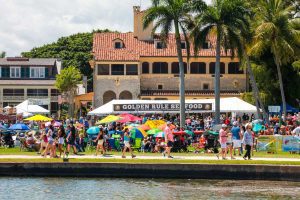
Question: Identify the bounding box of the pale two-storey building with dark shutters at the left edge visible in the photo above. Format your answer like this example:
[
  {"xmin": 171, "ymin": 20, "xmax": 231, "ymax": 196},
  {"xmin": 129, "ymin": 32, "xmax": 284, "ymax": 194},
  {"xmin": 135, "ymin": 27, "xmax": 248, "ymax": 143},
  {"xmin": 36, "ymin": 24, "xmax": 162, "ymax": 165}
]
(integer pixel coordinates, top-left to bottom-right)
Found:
[{"xmin": 0, "ymin": 57, "xmax": 61, "ymax": 113}]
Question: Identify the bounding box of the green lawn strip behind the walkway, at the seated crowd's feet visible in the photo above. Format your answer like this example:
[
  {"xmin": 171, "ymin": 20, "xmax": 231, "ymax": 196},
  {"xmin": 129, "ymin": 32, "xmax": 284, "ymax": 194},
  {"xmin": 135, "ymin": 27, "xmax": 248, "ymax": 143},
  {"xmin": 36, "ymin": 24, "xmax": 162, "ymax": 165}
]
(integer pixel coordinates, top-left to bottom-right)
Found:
[{"xmin": 0, "ymin": 147, "xmax": 300, "ymax": 159}]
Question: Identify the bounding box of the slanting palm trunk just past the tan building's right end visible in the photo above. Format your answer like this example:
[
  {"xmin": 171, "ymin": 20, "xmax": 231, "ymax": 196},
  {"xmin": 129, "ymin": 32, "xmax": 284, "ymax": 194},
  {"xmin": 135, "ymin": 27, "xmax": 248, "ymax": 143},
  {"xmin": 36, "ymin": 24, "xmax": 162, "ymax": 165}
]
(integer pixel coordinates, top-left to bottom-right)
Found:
[{"xmin": 244, "ymin": 53, "xmax": 270, "ymax": 124}]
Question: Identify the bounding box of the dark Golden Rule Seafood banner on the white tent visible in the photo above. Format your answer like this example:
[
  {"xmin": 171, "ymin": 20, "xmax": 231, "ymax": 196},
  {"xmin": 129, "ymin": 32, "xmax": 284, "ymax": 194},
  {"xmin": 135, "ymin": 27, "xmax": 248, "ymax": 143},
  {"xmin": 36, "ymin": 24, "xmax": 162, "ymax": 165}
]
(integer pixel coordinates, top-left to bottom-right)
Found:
[{"xmin": 113, "ymin": 103, "xmax": 212, "ymax": 112}]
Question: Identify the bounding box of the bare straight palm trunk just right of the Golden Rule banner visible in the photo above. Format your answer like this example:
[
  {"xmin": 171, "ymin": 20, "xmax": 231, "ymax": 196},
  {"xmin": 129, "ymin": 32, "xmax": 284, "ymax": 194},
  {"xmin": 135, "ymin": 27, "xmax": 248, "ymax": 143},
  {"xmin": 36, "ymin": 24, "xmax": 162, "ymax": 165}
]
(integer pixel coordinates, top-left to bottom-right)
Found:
[{"xmin": 215, "ymin": 30, "xmax": 221, "ymax": 124}]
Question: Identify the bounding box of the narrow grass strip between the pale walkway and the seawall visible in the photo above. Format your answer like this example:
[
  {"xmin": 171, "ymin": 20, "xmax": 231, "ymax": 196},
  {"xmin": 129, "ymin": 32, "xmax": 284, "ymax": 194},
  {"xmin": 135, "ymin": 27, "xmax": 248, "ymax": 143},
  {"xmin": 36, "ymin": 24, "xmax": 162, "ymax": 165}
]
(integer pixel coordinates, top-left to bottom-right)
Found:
[{"xmin": 0, "ymin": 158, "xmax": 300, "ymax": 166}]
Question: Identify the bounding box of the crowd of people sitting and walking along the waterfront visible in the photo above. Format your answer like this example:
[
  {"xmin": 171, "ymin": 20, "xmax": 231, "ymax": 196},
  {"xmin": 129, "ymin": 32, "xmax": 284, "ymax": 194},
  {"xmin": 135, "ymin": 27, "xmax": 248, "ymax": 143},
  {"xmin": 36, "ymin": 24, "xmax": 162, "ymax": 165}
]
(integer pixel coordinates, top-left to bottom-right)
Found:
[{"xmin": 2, "ymin": 113, "xmax": 300, "ymax": 160}]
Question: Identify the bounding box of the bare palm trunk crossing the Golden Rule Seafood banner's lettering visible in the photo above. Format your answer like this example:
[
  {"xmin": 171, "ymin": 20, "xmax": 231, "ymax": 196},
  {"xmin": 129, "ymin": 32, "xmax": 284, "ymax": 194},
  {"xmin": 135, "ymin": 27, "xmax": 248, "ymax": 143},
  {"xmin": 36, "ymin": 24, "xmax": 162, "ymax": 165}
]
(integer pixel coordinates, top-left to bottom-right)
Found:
[{"xmin": 174, "ymin": 21, "xmax": 185, "ymax": 128}]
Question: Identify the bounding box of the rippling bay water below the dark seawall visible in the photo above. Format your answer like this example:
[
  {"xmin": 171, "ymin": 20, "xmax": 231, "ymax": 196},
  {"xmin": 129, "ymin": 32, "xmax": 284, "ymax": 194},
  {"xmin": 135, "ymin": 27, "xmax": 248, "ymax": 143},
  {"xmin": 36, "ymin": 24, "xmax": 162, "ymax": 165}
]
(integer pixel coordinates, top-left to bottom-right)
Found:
[{"xmin": 0, "ymin": 177, "xmax": 300, "ymax": 200}]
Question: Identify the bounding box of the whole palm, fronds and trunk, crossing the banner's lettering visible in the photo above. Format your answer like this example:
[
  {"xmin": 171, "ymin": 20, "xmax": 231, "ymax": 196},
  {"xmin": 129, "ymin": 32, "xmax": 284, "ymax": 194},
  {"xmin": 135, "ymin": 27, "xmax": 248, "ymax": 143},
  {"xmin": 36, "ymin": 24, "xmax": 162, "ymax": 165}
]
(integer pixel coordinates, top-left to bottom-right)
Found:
[{"xmin": 143, "ymin": 0, "xmax": 205, "ymax": 127}]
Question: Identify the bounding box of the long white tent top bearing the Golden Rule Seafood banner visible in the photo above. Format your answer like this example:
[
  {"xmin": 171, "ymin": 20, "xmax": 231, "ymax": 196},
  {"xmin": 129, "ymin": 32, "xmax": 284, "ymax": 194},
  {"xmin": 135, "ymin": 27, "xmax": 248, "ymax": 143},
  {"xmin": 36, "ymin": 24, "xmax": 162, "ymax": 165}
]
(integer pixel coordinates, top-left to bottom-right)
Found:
[{"xmin": 88, "ymin": 97, "xmax": 256, "ymax": 116}]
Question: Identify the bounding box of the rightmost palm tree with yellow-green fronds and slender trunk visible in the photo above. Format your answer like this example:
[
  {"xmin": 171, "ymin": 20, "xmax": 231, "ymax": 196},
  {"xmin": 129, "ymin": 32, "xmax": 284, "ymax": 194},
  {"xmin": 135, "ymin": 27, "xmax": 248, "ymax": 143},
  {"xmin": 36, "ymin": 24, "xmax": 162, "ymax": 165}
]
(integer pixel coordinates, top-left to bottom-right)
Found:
[{"xmin": 250, "ymin": 0, "xmax": 300, "ymax": 119}]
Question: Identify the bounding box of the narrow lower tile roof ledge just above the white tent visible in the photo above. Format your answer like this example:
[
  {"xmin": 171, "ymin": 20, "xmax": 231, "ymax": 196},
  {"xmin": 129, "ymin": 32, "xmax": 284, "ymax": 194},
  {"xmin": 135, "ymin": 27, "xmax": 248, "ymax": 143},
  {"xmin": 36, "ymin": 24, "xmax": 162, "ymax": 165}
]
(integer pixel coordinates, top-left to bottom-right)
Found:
[{"xmin": 141, "ymin": 90, "xmax": 240, "ymax": 96}]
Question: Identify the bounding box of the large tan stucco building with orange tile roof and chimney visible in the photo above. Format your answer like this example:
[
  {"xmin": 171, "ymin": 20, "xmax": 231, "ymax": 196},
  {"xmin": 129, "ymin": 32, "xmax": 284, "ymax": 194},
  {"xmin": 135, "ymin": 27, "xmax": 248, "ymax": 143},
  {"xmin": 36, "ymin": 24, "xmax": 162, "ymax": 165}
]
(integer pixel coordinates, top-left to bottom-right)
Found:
[{"xmin": 91, "ymin": 7, "xmax": 246, "ymax": 107}]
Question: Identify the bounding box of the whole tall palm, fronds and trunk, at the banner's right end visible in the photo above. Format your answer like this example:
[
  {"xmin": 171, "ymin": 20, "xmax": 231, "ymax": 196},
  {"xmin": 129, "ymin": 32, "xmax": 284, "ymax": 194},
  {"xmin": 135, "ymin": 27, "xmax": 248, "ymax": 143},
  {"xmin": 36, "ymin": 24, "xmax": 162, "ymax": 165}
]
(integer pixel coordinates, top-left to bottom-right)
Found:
[{"xmin": 192, "ymin": 0, "xmax": 248, "ymax": 124}]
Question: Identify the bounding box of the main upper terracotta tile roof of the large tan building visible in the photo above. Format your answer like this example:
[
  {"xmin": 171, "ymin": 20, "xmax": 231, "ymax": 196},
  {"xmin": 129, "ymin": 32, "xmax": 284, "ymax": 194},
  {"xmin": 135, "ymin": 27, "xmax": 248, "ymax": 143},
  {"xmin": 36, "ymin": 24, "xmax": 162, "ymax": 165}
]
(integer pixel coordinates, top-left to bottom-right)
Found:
[{"xmin": 93, "ymin": 33, "xmax": 229, "ymax": 61}]
